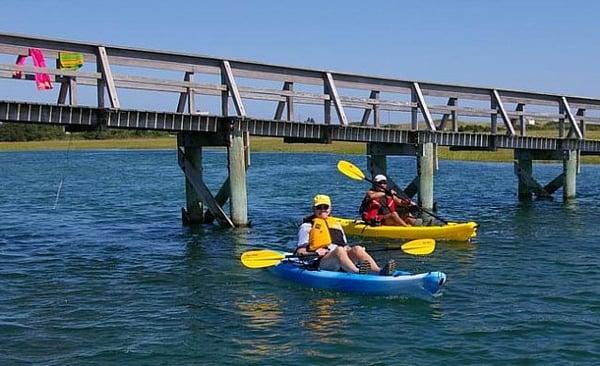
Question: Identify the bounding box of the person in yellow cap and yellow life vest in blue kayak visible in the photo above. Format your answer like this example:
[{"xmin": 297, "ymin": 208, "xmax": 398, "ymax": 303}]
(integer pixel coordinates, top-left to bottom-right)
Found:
[{"xmin": 296, "ymin": 194, "xmax": 396, "ymax": 275}]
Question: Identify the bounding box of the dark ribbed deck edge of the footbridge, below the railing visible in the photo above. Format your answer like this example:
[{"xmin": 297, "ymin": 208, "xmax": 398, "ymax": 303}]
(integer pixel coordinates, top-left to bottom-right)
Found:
[{"xmin": 0, "ymin": 101, "xmax": 600, "ymax": 155}]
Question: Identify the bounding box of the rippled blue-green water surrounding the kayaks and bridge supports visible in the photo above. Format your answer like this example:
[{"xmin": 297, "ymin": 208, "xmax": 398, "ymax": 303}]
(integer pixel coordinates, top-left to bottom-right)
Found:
[{"xmin": 0, "ymin": 151, "xmax": 600, "ymax": 365}]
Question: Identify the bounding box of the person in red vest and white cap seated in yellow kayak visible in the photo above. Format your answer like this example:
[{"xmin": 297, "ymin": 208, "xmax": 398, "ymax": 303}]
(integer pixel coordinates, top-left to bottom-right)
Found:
[{"xmin": 359, "ymin": 174, "xmax": 422, "ymax": 226}]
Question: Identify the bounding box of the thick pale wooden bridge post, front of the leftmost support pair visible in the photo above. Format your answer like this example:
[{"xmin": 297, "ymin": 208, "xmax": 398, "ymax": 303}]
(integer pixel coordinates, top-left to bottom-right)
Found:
[{"xmin": 227, "ymin": 130, "xmax": 249, "ymax": 227}]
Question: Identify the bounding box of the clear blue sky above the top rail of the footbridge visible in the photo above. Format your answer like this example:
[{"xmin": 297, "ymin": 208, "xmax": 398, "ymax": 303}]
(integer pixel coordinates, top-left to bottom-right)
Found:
[{"xmin": 0, "ymin": 0, "xmax": 600, "ymax": 106}]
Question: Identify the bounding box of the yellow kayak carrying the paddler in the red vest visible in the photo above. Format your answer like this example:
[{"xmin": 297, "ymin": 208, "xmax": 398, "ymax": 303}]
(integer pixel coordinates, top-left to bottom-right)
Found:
[{"xmin": 335, "ymin": 217, "xmax": 477, "ymax": 241}]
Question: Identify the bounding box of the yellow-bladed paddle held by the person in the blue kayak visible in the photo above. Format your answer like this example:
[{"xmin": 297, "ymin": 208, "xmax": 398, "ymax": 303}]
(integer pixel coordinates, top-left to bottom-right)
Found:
[{"xmin": 241, "ymin": 239, "xmax": 435, "ymax": 268}]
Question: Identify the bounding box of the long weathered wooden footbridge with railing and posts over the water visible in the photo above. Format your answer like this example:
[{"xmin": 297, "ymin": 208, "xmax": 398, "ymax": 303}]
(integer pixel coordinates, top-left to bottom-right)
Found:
[{"xmin": 0, "ymin": 33, "xmax": 600, "ymax": 226}]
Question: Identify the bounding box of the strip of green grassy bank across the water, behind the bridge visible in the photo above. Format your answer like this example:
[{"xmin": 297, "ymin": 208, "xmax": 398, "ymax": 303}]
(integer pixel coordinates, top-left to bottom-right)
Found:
[{"xmin": 0, "ymin": 136, "xmax": 600, "ymax": 164}]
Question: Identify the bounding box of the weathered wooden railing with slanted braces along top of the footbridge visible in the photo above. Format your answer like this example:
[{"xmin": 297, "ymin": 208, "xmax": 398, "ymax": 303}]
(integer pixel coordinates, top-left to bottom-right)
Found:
[{"xmin": 0, "ymin": 33, "xmax": 600, "ymax": 140}]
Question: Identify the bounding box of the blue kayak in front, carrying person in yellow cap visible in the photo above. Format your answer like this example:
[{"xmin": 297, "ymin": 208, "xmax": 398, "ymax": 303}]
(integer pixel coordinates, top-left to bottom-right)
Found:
[{"xmin": 269, "ymin": 260, "xmax": 446, "ymax": 299}]
